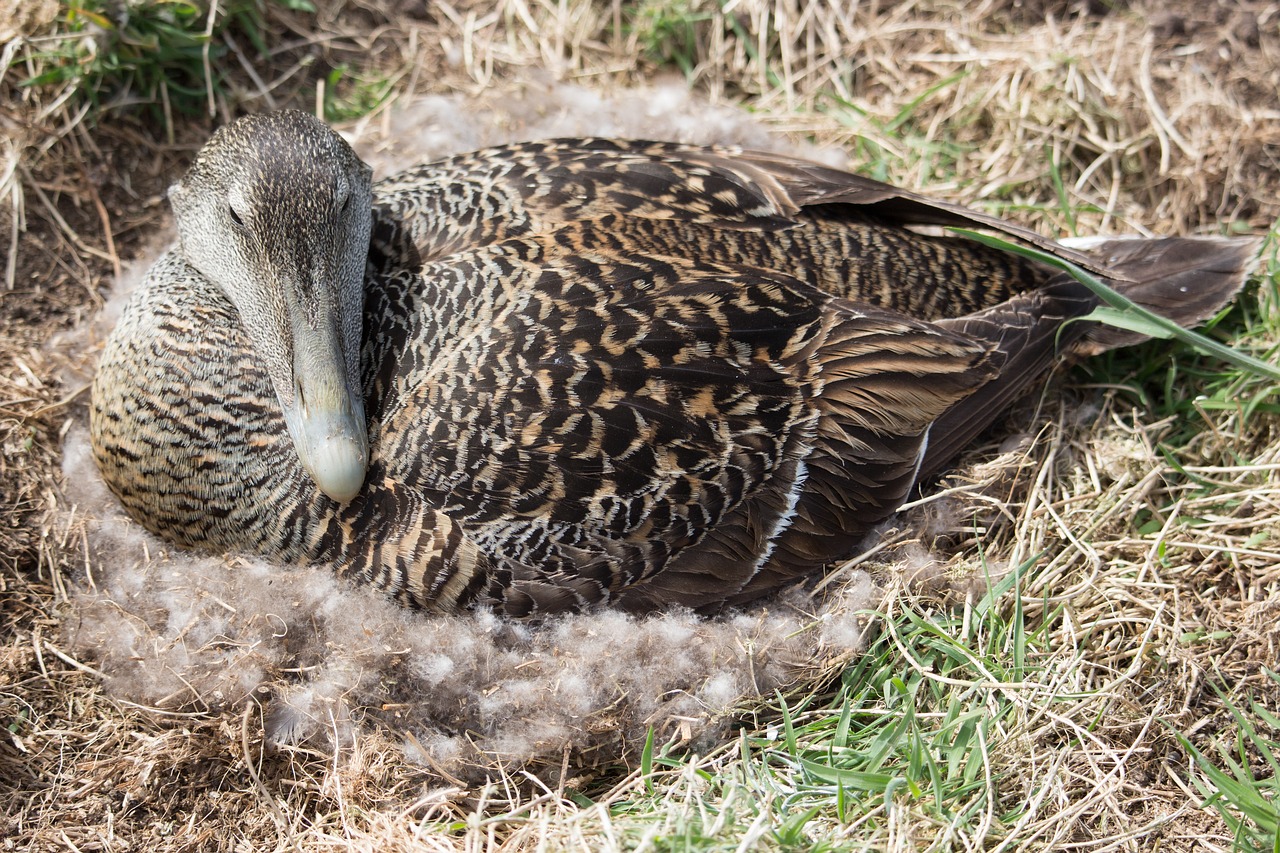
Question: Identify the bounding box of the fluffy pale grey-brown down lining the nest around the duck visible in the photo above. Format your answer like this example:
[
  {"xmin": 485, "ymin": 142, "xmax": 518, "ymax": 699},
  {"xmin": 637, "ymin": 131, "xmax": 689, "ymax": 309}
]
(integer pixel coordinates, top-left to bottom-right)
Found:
[{"xmin": 64, "ymin": 86, "xmax": 877, "ymax": 776}]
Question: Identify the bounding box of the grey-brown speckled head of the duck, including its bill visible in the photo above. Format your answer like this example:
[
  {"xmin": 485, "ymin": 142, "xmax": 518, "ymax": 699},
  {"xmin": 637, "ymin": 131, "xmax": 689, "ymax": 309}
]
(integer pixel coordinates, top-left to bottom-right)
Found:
[{"xmin": 169, "ymin": 110, "xmax": 372, "ymax": 502}]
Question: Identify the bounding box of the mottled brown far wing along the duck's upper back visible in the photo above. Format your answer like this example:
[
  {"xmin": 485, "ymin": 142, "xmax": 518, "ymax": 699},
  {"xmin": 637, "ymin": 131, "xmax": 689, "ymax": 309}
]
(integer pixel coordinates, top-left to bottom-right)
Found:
[{"xmin": 375, "ymin": 138, "xmax": 1105, "ymax": 273}]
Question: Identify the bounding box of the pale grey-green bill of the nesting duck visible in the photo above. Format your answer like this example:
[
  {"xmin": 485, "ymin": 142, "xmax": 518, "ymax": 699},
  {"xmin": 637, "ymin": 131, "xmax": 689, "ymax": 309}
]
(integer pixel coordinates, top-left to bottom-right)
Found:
[{"xmin": 284, "ymin": 322, "xmax": 369, "ymax": 503}]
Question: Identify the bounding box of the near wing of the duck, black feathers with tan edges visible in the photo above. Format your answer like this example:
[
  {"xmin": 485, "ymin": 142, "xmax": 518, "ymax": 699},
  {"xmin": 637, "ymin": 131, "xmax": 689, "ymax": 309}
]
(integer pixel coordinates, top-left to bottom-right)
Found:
[{"xmin": 334, "ymin": 216, "xmax": 998, "ymax": 615}]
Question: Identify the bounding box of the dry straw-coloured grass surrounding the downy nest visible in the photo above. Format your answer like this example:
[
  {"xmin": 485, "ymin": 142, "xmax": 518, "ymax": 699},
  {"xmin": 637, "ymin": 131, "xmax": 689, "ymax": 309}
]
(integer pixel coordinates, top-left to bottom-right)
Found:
[{"xmin": 0, "ymin": 0, "xmax": 1280, "ymax": 850}]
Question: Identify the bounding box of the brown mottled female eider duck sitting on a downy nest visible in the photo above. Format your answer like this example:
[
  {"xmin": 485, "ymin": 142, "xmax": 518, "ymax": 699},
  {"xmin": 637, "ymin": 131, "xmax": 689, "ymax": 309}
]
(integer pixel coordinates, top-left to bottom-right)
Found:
[{"xmin": 91, "ymin": 111, "xmax": 1256, "ymax": 617}]
